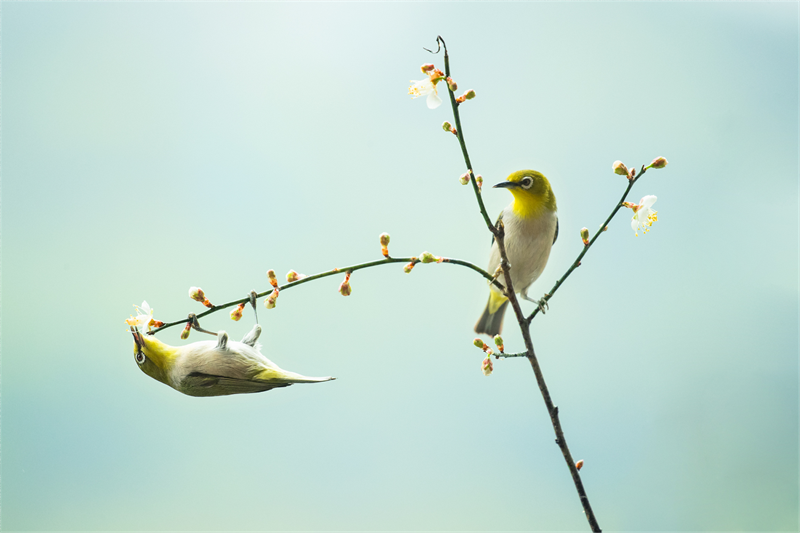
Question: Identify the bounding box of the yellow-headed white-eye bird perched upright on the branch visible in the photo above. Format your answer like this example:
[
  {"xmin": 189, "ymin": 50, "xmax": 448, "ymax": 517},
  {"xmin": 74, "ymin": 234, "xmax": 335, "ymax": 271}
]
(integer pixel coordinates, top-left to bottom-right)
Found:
[{"xmin": 475, "ymin": 170, "xmax": 558, "ymax": 336}]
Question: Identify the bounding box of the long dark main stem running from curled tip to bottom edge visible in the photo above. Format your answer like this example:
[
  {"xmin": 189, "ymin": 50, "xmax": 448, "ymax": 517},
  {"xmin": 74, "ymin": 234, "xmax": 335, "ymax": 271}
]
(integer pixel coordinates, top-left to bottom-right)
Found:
[{"xmin": 437, "ymin": 37, "xmax": 600, "ymax": 533}]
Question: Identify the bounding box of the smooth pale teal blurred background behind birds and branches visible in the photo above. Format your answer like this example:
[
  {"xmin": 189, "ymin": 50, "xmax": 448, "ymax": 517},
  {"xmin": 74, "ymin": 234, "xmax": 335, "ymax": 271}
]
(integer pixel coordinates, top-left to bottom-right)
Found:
[{"xmin": 0, "ymin": 2, "xmax": 800, "ymax": 531}]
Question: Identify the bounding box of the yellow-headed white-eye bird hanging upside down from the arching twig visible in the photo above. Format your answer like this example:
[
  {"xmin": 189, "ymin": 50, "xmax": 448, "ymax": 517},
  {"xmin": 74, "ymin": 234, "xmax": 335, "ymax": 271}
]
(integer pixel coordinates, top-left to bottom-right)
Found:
[{"xmin": 131, "ymin": 324, "xmax": 336, "ymax": 396}]
